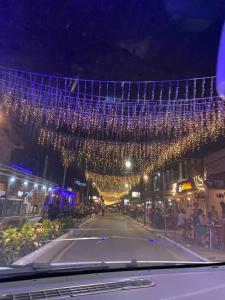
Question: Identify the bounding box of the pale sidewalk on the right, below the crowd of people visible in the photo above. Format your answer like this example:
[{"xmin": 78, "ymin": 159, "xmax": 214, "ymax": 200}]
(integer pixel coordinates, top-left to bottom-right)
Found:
[{"xmin": 128, "ymin": 216, "xmax": 225, "ymax": 262}]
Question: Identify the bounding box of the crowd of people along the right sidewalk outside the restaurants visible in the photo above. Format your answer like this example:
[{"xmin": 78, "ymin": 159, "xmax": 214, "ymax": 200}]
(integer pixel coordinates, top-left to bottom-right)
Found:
[{"xmin": 126, "ymin": 202, "xmax": 225, "ymax": 248}]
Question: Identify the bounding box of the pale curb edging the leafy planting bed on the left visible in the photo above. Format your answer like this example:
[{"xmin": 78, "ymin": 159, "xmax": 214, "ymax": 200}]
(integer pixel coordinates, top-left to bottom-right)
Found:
[{"xmin": 12, "ymin": 217, "xmax": 94, "ymax": 266}]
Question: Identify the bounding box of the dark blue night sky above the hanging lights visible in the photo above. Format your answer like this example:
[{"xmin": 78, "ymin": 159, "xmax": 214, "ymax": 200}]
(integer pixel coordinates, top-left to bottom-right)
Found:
[{"xmin": 0, "ymin": 0, "xmax": 225, "ymax": 184}]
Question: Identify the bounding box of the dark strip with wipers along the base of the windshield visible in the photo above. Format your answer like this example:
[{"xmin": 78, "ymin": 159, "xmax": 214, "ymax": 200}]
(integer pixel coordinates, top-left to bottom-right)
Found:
[{"xmin": 0, "ymin": 259, "xmax": 221, "ymax": 282}]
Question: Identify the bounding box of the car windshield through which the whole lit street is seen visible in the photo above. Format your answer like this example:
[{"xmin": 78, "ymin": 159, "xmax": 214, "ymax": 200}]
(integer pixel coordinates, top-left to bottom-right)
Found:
[{"xmin": 0, "ymin": 0, "xmax": 225, "ymax": 272}]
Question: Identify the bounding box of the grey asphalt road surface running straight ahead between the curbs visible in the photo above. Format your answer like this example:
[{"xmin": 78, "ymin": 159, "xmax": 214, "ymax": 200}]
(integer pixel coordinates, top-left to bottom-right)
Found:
[{"xmin": 38, "ymin": 213, "xmax": 202, "ymax": 263}]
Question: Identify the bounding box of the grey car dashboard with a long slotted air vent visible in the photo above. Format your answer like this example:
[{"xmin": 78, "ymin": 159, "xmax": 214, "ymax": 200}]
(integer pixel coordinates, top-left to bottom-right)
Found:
[{"xmin": 0, "ymin": 266, "xmax": 225, "ymax": 300}]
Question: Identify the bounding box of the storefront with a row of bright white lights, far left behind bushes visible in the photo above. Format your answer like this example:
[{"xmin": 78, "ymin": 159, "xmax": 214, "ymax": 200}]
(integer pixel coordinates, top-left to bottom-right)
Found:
[{"xmin": 0, "ymin": 164, "xmax": 54, "ymax": 217}]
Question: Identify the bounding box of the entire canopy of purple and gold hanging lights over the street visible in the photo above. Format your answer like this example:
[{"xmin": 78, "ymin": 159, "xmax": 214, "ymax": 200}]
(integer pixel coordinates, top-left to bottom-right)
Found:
[{"xmin": 0, "ymin": 67, "xmax": 225, "ymax": 201}]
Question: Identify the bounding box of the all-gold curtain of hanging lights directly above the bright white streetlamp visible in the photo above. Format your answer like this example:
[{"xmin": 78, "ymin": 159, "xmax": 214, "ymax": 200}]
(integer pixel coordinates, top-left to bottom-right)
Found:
[{"xmin": 38, "ymin": 128, "xmax": 169, "ymax": 174}]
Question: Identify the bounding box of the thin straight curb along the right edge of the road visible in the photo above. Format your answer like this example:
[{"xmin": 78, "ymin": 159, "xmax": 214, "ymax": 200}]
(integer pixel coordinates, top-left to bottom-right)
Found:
[{"xmin": 126, "ymin": 216, "xmax": 209, "ymax": 262}]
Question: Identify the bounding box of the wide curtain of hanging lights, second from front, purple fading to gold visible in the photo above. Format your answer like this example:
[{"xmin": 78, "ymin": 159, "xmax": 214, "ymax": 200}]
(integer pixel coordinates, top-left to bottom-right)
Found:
[{"xmin": 5, "ymin": 96, "xmax": 225, "ymax": 142}]
